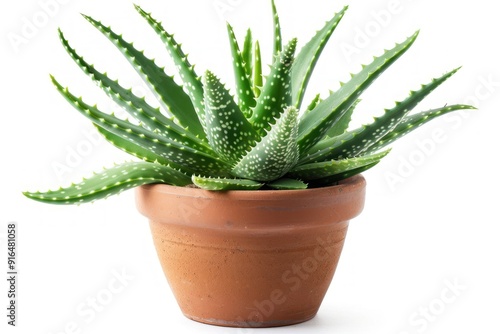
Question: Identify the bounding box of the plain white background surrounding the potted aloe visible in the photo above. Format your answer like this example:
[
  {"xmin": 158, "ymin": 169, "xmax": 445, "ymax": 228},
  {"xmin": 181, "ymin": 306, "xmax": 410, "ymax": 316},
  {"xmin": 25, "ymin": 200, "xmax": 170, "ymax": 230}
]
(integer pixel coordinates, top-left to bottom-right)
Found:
[{"xmin": 0, "ymin": 0, "xmax": 500, "ymax": 334}]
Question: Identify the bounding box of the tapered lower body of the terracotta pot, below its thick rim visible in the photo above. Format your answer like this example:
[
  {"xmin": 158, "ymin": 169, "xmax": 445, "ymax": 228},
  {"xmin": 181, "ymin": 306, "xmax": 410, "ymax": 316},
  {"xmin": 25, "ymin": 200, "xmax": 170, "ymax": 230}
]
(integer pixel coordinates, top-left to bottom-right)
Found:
[{"xmin": 150, "ymin": 221, "xmax": 348, "ymax": 327}]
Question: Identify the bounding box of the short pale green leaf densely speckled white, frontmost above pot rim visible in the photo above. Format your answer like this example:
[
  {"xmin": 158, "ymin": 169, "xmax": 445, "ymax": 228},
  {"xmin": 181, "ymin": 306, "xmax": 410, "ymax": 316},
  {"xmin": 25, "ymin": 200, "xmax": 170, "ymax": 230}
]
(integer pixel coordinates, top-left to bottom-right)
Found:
[{"xmin": 232, "ymin": 107, "xmax": 298, "ymax": 181}]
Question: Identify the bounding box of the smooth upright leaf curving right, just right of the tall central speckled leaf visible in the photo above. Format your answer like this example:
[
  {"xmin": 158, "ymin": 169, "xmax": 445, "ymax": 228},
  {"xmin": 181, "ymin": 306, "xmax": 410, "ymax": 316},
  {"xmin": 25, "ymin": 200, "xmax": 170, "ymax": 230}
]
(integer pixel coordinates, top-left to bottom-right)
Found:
[{"xmin": 292, "ymin": 6, "xmax": 348, "ymax": 109}]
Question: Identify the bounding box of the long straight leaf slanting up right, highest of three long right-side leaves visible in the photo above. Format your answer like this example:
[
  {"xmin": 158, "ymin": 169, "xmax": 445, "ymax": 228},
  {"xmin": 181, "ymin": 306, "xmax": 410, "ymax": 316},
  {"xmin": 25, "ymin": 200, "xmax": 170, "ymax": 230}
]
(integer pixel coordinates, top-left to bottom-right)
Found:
[{"xmin": 299, "ymin": 32, "xmax": 418, "ymax": 156}]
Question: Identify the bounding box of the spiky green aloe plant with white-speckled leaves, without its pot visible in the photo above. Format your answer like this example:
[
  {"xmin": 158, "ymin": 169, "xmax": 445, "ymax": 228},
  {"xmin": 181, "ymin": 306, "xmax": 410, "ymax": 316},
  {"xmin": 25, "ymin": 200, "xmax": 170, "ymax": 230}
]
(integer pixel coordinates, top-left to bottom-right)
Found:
[{"xmin": 25, "ymin": 1, "xmax": 473, "ymax": 204}]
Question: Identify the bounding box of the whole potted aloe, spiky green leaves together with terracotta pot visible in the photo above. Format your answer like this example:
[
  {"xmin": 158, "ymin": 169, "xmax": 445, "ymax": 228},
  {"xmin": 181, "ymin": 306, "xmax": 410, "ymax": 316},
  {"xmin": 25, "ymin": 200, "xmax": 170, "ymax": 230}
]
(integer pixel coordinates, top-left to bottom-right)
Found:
[{"xmin": 25, "ymin": 2, "xmax": 474, "ymax": 327}]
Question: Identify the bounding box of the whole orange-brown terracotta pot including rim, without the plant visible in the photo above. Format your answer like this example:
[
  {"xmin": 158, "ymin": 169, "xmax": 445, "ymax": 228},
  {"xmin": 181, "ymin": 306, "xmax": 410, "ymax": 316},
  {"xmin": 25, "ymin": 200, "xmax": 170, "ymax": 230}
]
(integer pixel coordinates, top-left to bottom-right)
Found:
[{"xmin": 136, "ymin": 175, "xmax": 366, "ymax": 327}]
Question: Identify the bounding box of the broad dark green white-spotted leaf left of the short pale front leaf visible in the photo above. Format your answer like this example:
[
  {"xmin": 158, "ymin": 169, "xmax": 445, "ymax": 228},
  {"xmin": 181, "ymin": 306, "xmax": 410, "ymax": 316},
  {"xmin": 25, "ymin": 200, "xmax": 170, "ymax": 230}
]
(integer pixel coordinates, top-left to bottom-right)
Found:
[{"xmin": 204, "ymin": 71, "xmax": 259, "ymax": 164}]
